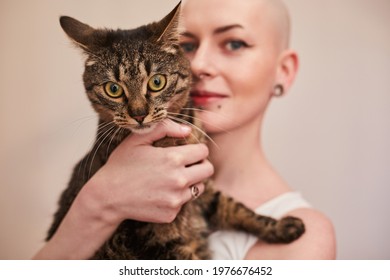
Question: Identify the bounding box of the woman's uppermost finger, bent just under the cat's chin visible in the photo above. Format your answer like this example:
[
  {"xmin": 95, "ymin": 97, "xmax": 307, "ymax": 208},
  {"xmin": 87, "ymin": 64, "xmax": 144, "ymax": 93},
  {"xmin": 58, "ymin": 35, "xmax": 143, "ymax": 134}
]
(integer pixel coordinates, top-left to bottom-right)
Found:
[{"xmin": 131, "ymin": 120, "xmax": 191, "ymax": 145}]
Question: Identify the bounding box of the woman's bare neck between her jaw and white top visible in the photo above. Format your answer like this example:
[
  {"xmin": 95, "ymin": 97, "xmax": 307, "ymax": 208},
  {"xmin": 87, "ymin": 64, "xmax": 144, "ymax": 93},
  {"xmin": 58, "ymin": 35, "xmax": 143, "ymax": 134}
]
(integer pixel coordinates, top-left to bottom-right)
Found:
[{"xmin": 209, "ymin": 116, "xmax": 288, "ymax": 208}]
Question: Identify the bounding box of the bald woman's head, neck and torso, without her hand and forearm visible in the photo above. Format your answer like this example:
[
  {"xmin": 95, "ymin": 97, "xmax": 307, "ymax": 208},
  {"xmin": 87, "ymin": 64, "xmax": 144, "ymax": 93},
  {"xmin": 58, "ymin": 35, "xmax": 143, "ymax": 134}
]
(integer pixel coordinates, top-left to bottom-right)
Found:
[{"xmin": 181, "ymin": 0, "xmax": 335, "ymax": 259}]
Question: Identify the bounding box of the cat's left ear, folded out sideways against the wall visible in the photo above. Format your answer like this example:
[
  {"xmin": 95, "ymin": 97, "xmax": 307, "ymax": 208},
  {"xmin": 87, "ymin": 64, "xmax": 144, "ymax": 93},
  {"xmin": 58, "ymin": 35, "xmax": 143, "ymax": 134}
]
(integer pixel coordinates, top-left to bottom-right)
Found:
[{"xmin": 60, "ymin": 16, "xmax": 106, "ymax": 52}]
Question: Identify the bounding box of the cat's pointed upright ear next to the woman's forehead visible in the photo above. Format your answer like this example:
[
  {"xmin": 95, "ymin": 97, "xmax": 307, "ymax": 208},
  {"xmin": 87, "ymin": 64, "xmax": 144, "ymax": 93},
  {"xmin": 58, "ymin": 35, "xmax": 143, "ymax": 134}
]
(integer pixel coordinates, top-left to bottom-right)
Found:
[{"xmin": 157, "ymin": 1, "xmax": 181, "ymax": 49}]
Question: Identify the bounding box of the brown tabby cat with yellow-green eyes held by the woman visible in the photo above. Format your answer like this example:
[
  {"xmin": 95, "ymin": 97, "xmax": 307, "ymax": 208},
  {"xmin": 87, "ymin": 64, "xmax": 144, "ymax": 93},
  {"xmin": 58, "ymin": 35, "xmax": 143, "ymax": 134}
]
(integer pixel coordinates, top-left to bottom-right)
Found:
[{"xmin": 47, "ymin": 3, "xmax": 304, "ymax": 259}]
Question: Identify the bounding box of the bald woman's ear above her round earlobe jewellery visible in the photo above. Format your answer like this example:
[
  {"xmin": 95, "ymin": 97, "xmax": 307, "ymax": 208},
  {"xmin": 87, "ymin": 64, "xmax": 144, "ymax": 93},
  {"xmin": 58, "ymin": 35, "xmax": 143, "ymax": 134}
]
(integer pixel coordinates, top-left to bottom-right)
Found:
[{"xmin": 276, "ymin": 49, "xmax": 299, "ymax": 92}]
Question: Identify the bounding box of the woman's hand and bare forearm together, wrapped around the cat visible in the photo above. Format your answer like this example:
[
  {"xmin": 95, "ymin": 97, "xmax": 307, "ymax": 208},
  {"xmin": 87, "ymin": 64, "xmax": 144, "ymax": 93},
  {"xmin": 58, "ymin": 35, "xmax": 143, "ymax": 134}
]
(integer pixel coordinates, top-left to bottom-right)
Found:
[{"xmin": 34, "ymin": 121, "xmax": 213, "ymax": 259}]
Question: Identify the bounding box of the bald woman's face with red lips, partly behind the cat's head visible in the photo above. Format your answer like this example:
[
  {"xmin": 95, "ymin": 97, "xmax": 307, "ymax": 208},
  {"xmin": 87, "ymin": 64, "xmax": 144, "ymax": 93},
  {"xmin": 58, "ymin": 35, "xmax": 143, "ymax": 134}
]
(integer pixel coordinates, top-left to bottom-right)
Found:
[{"xmin": 181, "ymin": 0, "xmax": 280, "ymax": 134}]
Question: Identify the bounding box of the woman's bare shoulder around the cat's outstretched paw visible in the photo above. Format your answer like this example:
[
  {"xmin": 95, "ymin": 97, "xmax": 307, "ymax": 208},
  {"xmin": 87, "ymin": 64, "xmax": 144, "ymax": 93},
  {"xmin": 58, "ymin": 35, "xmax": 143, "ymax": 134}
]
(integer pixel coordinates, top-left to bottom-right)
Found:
[{"xmin": 246, "ymin": 208, "xmax": 336, "ymax": 259}]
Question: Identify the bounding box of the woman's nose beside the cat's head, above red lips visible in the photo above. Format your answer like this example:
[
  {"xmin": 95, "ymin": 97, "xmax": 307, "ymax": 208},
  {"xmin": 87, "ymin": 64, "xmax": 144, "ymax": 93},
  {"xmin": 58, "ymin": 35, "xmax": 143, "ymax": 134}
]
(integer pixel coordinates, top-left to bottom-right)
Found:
[{"xmin": 191, "ymin": 44, "xmax": 216, "ymax": 78}]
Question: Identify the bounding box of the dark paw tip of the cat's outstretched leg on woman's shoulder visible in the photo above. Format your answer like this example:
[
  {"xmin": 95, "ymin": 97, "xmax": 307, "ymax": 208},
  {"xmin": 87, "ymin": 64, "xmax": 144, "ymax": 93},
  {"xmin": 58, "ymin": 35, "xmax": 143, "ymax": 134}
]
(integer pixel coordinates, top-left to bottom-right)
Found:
[{"xmin": 275, "ymin": 216, "xmax": 305, "ymax": 243}]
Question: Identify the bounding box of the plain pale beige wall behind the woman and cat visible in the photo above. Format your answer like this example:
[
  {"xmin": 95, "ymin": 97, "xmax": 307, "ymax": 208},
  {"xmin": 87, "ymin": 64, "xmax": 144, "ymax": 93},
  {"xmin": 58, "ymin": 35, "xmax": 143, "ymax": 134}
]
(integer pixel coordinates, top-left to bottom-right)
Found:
[{"xmin": 0, "ymin": 0, "xmax": 390, "ymax": 259}]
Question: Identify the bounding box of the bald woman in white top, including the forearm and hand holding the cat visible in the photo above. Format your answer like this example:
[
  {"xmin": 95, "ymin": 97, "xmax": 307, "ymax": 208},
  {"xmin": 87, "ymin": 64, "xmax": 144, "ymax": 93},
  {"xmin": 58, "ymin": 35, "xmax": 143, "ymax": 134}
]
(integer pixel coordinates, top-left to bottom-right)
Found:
[{"xmin": 36, "ymin": 0, "xmax": 335, "ymax": 259}]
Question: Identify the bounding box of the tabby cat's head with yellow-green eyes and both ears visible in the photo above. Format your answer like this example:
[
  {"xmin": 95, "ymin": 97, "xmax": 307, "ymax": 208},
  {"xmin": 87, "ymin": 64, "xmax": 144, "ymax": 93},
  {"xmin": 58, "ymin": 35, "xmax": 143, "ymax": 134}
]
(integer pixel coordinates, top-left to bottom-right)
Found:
[{"xmin": 60, "ymin": 3, "xmax": 191, "ymax": 133}]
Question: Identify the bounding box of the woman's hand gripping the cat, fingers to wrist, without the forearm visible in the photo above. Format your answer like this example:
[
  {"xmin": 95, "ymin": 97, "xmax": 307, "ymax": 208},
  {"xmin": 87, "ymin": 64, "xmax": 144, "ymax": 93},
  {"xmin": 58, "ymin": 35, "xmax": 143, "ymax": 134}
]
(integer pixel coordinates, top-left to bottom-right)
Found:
[{"xmin": 82, "ymin": 121, "xmax": 213, "ymax": 223}]
